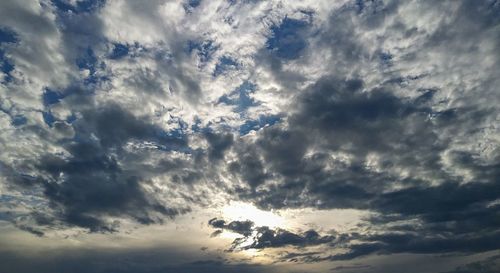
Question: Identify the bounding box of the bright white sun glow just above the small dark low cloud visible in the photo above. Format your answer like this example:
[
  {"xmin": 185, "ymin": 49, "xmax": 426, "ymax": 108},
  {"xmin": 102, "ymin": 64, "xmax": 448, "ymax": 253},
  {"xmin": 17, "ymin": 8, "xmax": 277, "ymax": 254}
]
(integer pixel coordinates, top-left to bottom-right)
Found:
[{"xmin": 222, "ymin": 202, "xmax": 286, "ymax": 228}]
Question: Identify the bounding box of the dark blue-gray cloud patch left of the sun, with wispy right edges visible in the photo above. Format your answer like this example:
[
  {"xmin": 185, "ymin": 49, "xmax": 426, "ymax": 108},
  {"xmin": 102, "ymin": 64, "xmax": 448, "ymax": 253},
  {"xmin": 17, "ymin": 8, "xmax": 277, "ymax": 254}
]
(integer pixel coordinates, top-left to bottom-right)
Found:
[{"xmin": 14, "ymin": 105, "xmax": 187, "ymax": 231}]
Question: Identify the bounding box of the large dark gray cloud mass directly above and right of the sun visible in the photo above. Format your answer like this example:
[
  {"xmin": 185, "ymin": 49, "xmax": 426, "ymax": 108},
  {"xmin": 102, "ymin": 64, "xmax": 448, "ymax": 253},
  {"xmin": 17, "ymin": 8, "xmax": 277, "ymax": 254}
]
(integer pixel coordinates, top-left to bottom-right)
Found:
[{"xmin": 235, "ymin": 76, "xmax": 446, "ymax": 208}]
